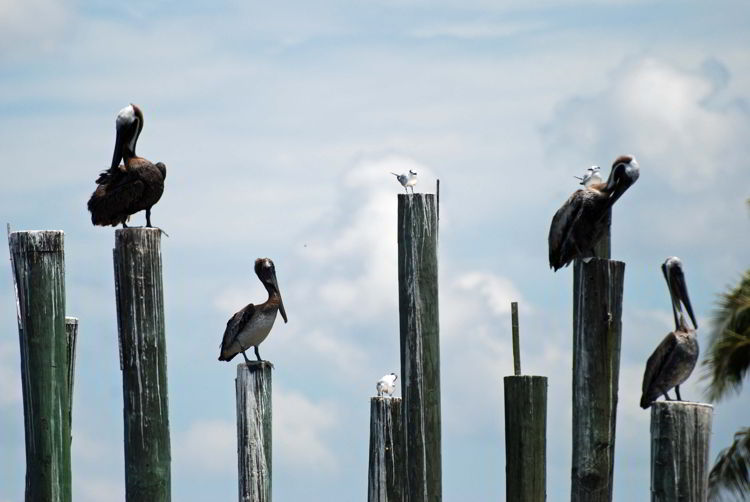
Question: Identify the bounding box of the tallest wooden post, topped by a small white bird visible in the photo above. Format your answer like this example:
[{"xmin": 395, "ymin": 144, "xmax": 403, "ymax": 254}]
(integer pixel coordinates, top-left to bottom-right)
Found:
[{"xmin": 398, "ymin": 193, "xmax": 442, "ymax": 502}]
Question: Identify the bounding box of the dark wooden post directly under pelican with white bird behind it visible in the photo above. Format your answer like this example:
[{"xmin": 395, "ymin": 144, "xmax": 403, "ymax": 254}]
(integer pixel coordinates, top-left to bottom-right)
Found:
[{"xmin": 571, "ymin": 258, "xmax": 625, "ymax": 502}]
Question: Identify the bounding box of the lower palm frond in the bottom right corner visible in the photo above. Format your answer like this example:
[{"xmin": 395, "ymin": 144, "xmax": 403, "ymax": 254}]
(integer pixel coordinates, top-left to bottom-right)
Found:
[{"xmin": 708, "ymin": 427, "xmax": 750, "ymax": 502}]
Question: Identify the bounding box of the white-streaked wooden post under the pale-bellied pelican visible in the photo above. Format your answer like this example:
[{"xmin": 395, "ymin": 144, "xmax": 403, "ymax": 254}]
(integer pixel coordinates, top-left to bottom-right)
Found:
[{"xmin": 235, "ymin": 361, "xmax": 272, "ymax": 502}]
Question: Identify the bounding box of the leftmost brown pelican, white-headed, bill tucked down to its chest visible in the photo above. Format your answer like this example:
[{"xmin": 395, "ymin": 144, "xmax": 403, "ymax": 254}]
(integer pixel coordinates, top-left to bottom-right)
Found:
[{"xmin": 88, "ymin": 104, "xmax": 167, "ymax": 228}]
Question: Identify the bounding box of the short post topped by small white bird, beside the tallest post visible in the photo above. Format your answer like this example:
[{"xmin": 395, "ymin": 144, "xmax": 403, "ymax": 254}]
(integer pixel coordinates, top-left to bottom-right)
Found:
[{"xmin": 367, "ymin": 397, "xmax": 406, "ymax": 502}]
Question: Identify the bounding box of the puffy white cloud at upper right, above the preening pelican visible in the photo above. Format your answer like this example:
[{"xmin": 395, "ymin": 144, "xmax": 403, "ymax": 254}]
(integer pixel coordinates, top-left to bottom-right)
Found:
[{"xmin": 548, "ymin": 58, "xmax": 750, "ymax": 193}]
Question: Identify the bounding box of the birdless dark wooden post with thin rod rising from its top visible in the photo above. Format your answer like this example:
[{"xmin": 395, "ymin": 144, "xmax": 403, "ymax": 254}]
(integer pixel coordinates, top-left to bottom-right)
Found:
[{"xmin": 503, "ymin": 302, "xmax": 547, "ymax": 502}]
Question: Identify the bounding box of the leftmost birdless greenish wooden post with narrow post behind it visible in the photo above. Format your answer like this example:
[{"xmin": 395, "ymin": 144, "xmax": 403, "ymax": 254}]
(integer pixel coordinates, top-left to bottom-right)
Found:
[{"xmin": 8, "ymin": 230, "xmax": 74, "ymax": 502}]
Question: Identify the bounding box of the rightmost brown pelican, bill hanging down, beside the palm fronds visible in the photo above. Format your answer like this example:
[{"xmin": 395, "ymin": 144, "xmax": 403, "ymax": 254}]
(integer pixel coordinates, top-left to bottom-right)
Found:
[{"xmin": 641, "ymin": 256, "xmax": 698, "ymax": 409}]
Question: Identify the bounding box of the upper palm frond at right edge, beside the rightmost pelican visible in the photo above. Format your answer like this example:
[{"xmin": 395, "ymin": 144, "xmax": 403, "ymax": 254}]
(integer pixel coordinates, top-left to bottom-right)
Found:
[{"xmin": 702, "ymin": 270, "xmax": 750, "ymax": 401}]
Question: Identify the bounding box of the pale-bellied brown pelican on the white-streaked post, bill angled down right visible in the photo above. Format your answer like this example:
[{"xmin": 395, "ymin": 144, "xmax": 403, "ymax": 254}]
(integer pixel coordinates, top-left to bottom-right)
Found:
[{"xmin": 219, "ymin": 258, "xmax": 287, "ymax": 363}]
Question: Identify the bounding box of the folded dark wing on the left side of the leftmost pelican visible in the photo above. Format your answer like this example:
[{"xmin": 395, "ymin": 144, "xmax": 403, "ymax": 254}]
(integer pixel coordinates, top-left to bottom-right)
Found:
[{"xmin": 88, "ymin": 168, "xmax": 144, "ymax": 226}]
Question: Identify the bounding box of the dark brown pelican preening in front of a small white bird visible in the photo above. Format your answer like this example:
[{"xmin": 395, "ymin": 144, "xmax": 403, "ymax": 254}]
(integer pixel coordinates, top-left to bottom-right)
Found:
[{"xmin": 549, "ymin": 155, "xmax": 639, "ymax": 271}]
